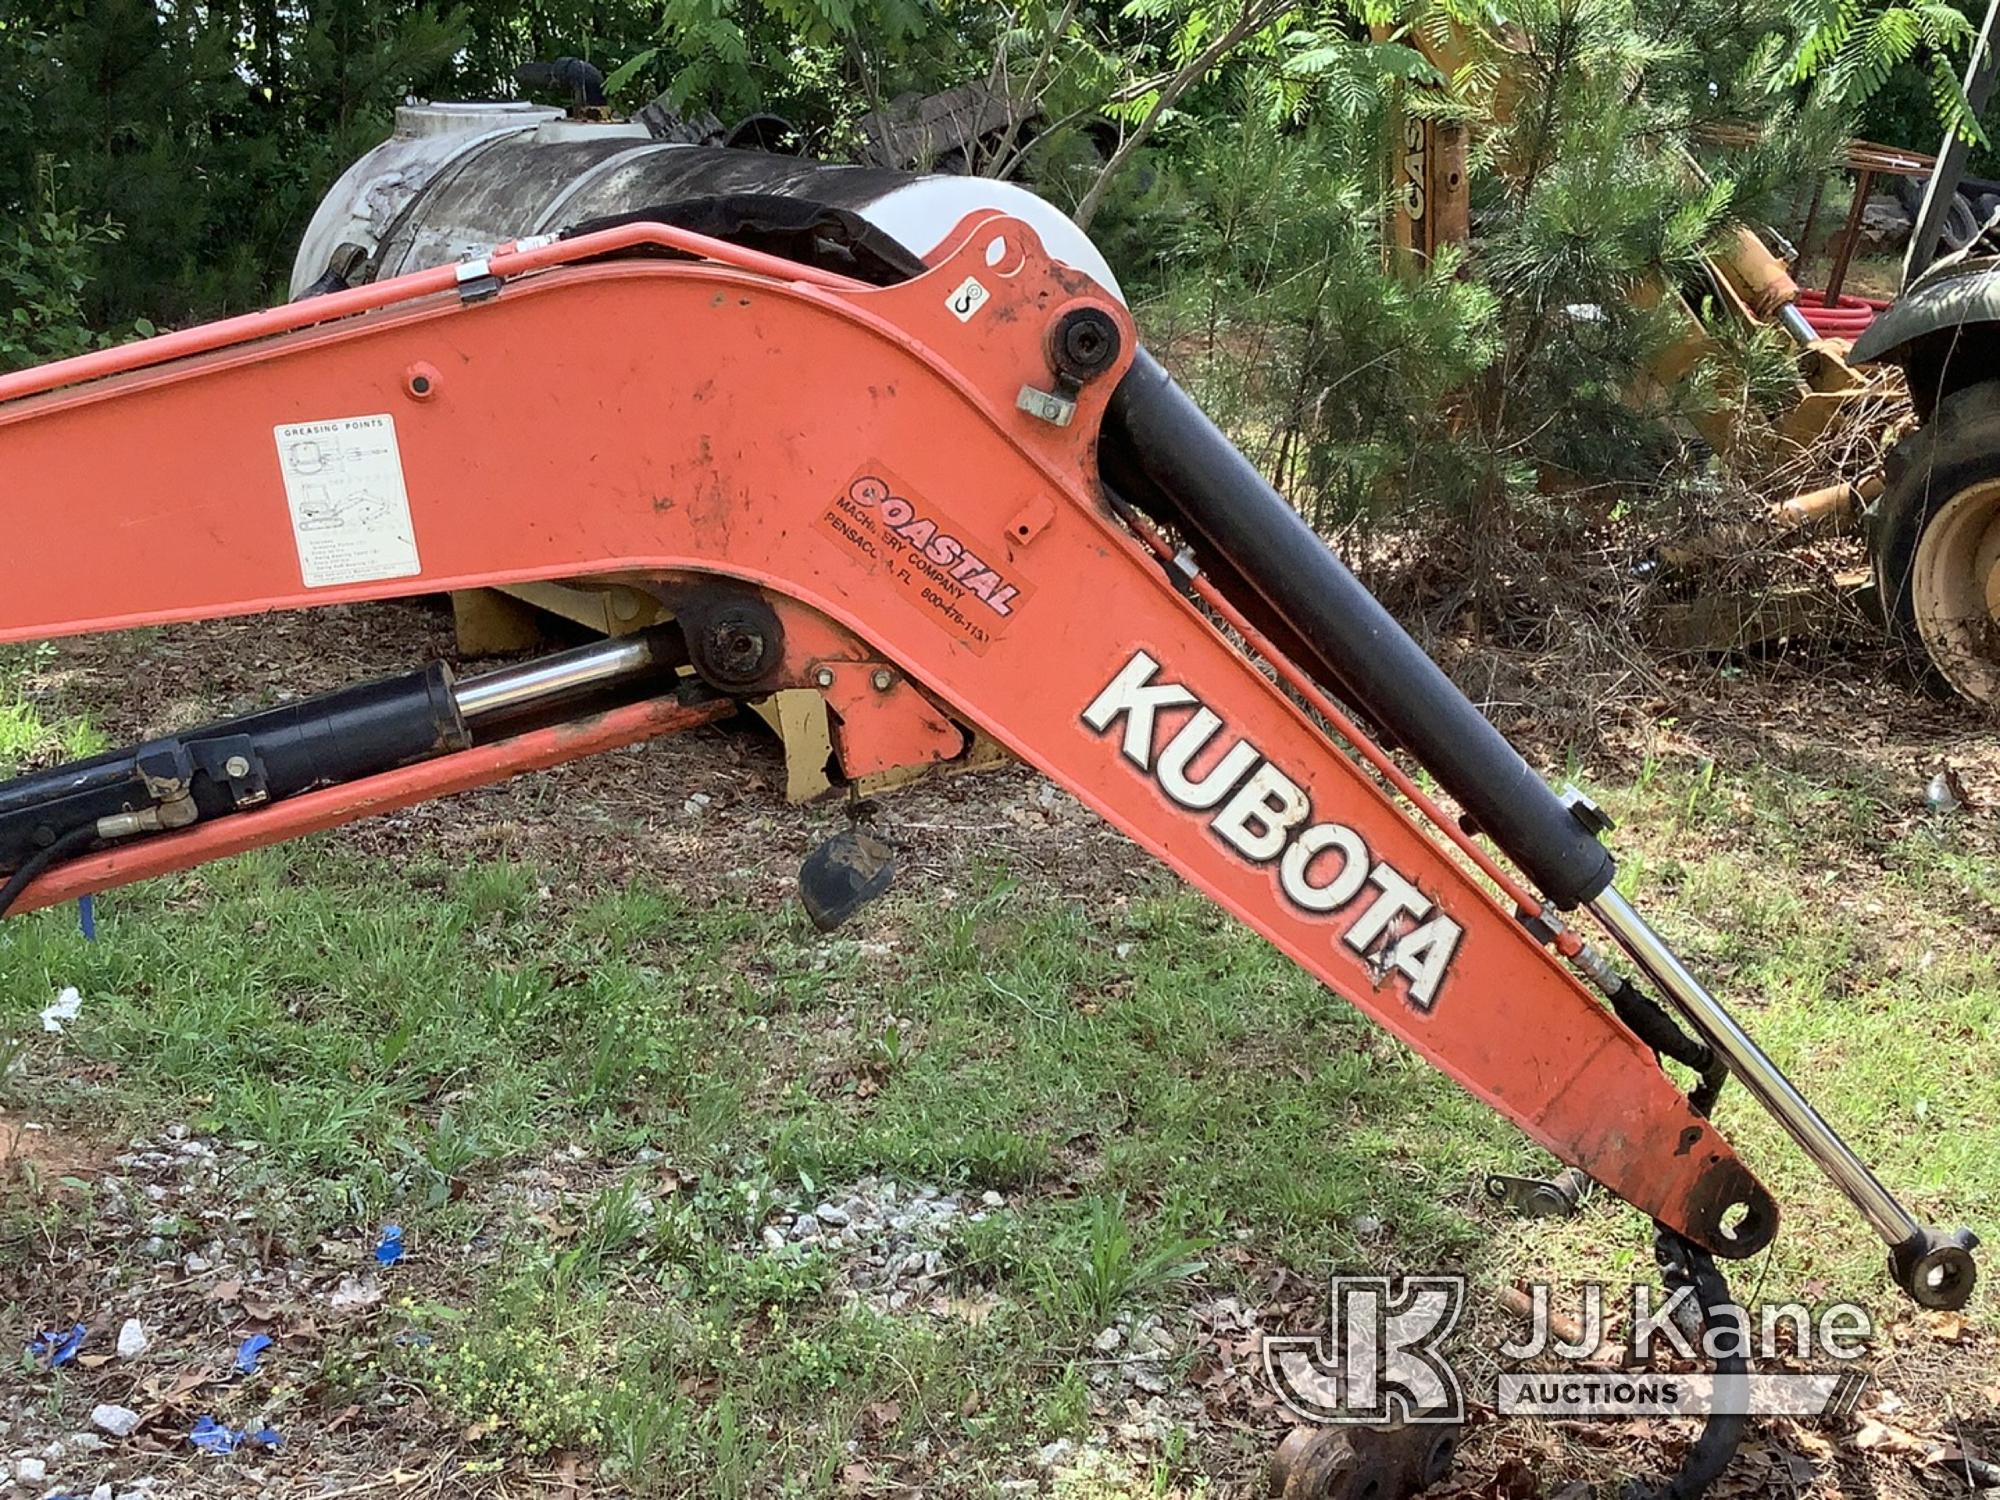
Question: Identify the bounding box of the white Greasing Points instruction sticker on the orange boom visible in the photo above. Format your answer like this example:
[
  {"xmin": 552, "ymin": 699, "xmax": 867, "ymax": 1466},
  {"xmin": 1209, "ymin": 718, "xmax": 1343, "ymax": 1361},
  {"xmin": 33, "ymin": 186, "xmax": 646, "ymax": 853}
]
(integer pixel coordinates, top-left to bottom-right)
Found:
[{"xmin": 272, "ymin": 412, "xmax": 424, "ymax": 588}]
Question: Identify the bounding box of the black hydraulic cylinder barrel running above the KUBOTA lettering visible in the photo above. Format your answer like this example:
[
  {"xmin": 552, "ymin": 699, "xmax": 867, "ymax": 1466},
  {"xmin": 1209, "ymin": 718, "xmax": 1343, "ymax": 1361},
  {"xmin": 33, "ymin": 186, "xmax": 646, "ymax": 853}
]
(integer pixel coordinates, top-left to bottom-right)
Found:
[{"xmin": 1102, "ymin": 350, "xmax": 1614, "ymax": 908}]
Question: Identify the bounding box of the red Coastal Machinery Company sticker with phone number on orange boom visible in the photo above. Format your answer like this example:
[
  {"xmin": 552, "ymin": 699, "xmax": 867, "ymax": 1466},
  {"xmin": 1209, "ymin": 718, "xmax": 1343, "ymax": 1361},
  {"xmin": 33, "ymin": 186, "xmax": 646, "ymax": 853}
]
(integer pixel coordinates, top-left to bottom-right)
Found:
[{"xmin": 820, "ymin": 470, "xmax": 1028, "ymax": 652}]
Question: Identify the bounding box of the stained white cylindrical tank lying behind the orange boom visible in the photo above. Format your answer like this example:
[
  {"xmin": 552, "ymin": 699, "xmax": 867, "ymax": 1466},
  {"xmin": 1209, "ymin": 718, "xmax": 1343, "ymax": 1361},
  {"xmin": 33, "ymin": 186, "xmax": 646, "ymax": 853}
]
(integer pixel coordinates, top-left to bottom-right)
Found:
[{"xmin": 292, "ymin": 102, "xmax": 1118, "ymax": 298}]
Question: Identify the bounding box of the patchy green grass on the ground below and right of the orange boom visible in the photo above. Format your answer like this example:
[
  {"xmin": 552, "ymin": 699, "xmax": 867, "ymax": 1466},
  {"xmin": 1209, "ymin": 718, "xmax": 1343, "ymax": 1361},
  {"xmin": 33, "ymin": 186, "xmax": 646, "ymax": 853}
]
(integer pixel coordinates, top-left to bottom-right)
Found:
[{"xmin": 0, "ymin": 728, "xmax": 2000, "ymax": 1494}]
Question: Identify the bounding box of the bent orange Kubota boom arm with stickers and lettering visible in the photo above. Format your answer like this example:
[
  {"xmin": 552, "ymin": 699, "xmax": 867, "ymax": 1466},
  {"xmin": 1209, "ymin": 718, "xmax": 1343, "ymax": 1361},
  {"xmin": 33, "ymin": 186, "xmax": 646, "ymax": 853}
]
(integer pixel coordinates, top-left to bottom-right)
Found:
[{"xmin": 0, "ymin": 214, "xmax": 1968, "ymax": 1312}]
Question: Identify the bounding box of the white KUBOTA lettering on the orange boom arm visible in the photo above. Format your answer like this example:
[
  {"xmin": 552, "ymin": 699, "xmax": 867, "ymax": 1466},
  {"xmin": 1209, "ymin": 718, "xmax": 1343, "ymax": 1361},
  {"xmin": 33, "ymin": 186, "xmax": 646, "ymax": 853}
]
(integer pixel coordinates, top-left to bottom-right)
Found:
[{"xmin": 1084, "ymin": 652, "xmax": 1464, "ymax": 1010}]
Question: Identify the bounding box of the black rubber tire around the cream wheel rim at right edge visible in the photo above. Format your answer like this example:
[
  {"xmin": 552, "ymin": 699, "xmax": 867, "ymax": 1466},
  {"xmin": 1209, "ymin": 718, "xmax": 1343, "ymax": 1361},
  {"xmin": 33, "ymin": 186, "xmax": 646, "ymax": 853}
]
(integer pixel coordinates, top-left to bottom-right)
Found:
[{"xmin": 1870, "ymin": 380, "xmax": 2000, "ymax": 704}]
